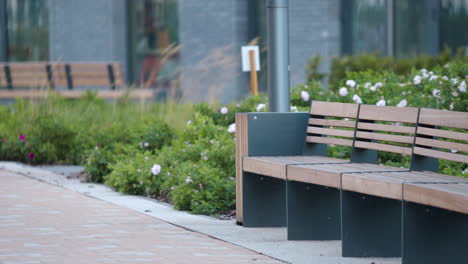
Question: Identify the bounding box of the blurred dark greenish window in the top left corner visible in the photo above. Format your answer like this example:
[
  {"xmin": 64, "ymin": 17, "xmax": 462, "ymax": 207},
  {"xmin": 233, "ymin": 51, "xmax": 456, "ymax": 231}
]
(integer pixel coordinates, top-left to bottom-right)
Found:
[{"xmin": 6, "ymin": 0, "xmax": 49, "ymax": 61}]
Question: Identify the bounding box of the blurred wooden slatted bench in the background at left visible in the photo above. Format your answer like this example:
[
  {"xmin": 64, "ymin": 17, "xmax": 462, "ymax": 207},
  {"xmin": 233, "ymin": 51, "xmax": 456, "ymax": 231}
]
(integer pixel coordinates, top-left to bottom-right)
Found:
[{"xmin": 0, "ymin": 62, "xmax": 154, "ymax": 99}]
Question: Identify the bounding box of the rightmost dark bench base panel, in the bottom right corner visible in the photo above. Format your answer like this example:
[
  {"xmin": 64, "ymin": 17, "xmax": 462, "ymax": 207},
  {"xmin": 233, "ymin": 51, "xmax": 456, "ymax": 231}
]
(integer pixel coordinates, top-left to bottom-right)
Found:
[{"xmin": 402, "ymin": 202, "xmax": 468, "ymax": 264}]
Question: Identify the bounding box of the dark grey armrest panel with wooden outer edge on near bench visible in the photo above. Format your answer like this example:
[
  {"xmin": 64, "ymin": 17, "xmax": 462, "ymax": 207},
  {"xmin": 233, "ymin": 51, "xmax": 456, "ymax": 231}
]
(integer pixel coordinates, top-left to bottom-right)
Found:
[{"xmin": 236, "ymin": 112, "xmax": 309, "ymax": 156}]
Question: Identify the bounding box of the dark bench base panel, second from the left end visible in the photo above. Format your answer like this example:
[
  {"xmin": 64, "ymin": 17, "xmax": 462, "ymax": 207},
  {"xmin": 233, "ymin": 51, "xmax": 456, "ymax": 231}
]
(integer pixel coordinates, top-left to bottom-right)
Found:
[{"xmin": 287, "ymin": 181, "xmax": 341, "ymax": 240}]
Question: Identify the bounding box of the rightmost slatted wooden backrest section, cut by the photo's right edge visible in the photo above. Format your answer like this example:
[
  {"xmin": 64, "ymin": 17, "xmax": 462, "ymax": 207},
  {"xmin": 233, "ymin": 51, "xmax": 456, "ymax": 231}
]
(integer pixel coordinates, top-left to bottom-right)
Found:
[{"xmin": 413, "ymin": 108, "xmax": 468, "ymax": 163}]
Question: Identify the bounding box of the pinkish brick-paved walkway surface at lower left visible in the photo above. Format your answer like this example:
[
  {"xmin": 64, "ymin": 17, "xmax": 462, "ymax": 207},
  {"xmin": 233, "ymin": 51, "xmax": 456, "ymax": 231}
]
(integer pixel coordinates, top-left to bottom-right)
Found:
[{"xmin": 0, "ymin": 170, "xmax": 282, "ymax": 264}]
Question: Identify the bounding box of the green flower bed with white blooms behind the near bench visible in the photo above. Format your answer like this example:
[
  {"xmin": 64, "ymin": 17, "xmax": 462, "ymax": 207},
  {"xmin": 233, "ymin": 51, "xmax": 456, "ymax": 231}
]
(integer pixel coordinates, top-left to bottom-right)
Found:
[{"xmin": 0, "ymin": 59, "xmax": 468, "ymax": 215}]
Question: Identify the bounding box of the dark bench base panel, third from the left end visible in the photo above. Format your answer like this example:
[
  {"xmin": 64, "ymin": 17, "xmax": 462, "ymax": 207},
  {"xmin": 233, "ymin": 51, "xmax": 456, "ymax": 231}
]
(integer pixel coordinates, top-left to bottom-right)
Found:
[{"xmin": 341, "ymin": 190, "xmax": 402, "ymax": 258}]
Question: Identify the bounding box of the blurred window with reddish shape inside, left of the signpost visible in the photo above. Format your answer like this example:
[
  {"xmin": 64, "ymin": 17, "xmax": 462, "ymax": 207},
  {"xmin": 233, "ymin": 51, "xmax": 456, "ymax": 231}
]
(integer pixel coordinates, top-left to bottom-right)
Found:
[{"xmin": 130, "ymin": 0, "xmax": 179, "ymax": 88}]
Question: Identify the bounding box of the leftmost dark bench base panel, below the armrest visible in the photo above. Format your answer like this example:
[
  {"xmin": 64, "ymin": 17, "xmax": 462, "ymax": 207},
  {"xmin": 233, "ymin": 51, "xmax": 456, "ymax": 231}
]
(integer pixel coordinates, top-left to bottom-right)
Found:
[{"xmin": 242, "ymin": 172, "xmax": 286, "ymax": 227}]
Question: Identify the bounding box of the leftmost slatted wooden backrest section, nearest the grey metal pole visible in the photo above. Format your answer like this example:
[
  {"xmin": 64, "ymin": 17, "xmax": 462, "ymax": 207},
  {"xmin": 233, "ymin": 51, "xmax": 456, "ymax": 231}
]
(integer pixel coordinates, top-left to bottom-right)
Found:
[{"xmin": 306, "ymin": 101, "xmax": 359, "ymax": 147}]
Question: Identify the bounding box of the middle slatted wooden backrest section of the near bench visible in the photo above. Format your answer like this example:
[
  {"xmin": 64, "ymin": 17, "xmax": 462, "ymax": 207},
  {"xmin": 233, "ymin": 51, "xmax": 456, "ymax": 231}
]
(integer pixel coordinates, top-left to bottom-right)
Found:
[{"xmin": 354, "ymin": 104, "xmax": 418, "ymax": 156}]
